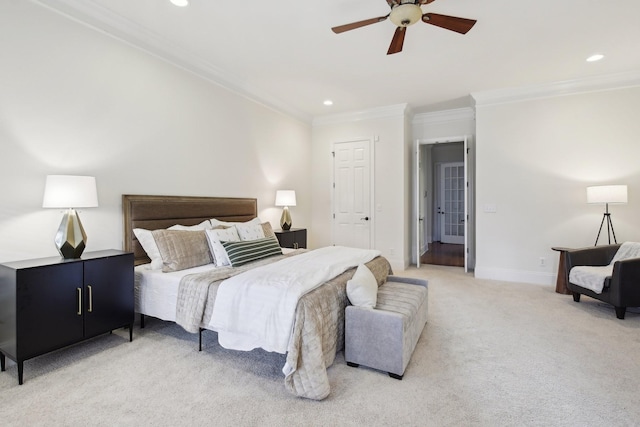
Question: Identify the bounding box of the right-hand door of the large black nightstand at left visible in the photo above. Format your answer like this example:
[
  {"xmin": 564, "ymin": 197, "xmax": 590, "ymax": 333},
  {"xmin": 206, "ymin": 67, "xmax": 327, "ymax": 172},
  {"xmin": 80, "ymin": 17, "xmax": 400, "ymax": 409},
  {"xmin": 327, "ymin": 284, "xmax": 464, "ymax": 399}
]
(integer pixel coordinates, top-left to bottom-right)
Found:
[{"xmin": 84, "ymin": 255, "xmax": 134, "ymax": 338}]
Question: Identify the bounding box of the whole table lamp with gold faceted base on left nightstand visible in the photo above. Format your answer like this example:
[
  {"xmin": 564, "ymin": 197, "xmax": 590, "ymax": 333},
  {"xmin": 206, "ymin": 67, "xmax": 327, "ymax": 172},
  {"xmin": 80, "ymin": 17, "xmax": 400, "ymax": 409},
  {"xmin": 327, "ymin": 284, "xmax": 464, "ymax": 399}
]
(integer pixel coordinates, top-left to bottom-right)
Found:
[{"xmin": 42, "ymin": 175, "xmax": 98, "ymax": 259}]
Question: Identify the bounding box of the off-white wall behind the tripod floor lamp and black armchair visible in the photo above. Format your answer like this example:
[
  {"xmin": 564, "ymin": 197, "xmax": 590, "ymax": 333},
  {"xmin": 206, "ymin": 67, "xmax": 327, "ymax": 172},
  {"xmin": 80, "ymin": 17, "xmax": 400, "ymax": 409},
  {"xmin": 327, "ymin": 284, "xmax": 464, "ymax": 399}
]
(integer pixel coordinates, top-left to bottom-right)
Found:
[{"xmin": 475, "ymin": 86, "xmax": 640, "ymax": 284}]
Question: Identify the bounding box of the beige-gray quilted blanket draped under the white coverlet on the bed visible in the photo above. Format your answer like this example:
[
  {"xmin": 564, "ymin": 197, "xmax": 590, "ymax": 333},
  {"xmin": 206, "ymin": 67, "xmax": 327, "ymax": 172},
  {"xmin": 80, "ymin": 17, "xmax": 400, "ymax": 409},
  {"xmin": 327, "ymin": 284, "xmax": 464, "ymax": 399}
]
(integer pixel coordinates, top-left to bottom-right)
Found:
[{"xmin": 176, "ymin": 252, "xmax": 391, "ymax": 400}]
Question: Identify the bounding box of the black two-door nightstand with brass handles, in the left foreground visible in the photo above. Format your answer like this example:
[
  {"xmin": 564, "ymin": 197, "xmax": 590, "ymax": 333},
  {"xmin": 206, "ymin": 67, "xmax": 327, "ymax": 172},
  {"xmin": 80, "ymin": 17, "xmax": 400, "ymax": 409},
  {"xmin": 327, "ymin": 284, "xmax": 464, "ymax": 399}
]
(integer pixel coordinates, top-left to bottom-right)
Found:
[{"xmin": 0, "ymin": 250, "xmax": 134, "ymax": 384}]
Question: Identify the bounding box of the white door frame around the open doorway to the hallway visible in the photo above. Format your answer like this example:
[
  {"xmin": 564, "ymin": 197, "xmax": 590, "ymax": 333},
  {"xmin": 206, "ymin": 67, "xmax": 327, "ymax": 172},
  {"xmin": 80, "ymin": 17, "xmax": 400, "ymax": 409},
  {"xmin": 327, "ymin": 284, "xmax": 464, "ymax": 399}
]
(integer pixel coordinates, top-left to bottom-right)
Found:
[{"xmin": 414, "ymin": 135, "xmax": 475, "ymax": 272}]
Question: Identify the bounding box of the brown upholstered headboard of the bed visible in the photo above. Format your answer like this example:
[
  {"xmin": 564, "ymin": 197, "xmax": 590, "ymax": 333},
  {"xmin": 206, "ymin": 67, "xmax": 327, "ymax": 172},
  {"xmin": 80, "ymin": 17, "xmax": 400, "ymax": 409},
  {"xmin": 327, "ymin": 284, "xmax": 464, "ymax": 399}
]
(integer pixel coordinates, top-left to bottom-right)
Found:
[{"xmin": 122, "ymin": 194, "xmax": 258, "ymax": 265}]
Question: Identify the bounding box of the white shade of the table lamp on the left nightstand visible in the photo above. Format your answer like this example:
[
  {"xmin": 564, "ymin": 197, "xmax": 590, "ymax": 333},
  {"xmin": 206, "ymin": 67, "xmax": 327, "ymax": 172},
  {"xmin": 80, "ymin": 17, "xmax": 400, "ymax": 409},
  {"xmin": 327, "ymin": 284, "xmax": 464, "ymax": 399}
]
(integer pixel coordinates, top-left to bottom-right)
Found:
[{"xmin": 42, "ymin": 175, "xmax": 98, "ymax": 208}]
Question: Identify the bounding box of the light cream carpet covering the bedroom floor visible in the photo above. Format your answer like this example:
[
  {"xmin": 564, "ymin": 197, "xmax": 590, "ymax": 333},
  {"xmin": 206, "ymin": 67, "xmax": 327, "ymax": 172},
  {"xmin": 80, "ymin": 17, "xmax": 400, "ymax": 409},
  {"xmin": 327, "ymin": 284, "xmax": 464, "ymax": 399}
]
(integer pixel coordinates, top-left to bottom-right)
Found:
[{"xmin": 0, "ymin": 266, "xmax": 640, "ymax": 426}]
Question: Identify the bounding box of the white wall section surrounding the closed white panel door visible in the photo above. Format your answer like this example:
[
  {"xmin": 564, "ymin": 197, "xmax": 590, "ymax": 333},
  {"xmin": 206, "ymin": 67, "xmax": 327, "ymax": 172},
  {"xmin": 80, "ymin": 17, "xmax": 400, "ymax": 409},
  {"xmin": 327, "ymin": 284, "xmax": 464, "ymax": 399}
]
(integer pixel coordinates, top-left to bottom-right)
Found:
[{"xmin": 310, "ymin": 105, "xmax": 410, "ymax": 271}]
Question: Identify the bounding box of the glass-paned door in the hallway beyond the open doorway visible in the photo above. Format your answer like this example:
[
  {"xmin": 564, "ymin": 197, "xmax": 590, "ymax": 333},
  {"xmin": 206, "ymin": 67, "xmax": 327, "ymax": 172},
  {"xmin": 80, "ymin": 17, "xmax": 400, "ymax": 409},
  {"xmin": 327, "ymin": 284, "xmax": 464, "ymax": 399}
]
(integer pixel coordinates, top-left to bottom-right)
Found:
[{"xmin": 440, "ymin": 162, "xmax": 466, "ymax": 244}]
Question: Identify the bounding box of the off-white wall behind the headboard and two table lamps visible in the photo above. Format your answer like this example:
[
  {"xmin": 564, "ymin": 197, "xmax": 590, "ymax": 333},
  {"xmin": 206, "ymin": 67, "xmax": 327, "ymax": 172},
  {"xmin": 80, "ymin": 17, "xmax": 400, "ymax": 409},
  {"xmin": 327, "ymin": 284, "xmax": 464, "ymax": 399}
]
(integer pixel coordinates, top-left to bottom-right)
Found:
[{"xmin": 0, "ymin": 1, "xmax": 312, "ymax": 262}]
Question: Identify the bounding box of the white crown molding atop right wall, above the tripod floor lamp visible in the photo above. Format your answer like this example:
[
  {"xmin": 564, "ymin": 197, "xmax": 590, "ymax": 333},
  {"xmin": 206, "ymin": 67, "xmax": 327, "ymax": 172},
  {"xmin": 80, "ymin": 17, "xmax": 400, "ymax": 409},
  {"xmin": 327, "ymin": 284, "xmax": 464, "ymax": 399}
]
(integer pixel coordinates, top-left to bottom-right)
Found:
[{"xmin": 471, "ymin": 71, "xmax": 640, "ymax": 107}]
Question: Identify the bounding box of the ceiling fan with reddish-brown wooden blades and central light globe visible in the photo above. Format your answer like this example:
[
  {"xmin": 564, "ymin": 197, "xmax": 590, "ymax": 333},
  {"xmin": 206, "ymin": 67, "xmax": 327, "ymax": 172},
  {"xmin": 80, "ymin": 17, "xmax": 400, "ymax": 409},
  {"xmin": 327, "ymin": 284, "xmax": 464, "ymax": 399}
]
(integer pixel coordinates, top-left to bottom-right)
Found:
[{"xmin": 331, "ymin": 0, "xmax": 476, "ymax": 55}]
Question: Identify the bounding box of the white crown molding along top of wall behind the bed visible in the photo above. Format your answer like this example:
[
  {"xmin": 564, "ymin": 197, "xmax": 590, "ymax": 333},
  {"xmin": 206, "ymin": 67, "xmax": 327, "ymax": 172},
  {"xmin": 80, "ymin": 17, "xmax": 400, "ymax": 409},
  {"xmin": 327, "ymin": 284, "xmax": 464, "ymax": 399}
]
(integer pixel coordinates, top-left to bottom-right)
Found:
[{"xmin": 32, "ymin": 0, "xmax": 311, "ymax": 123}]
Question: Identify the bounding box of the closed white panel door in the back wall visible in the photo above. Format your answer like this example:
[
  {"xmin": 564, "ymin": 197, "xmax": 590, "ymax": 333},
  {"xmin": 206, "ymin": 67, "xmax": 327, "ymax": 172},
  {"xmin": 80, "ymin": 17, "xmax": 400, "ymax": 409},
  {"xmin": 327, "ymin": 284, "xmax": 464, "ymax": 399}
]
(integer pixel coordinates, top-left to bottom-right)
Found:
[{"xmin": 333, "ymin": 140, "xmax": 371, "ymax": 249}]
